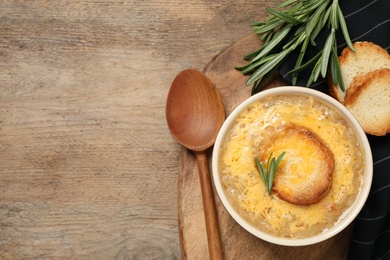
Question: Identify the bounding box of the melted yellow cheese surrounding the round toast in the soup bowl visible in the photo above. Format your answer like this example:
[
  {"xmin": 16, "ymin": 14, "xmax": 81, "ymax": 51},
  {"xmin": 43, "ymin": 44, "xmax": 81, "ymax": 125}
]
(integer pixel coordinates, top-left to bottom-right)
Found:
[{"xmin": 220, "ymin": 95, "xmax": 364, "ymax": 238}]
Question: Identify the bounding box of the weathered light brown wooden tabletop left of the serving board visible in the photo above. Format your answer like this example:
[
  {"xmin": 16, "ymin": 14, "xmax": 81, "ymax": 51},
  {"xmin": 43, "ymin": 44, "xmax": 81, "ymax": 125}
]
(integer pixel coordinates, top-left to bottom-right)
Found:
[{"xmin": 0, "ymin": 0, "xmax": 338, "ymax": 259}]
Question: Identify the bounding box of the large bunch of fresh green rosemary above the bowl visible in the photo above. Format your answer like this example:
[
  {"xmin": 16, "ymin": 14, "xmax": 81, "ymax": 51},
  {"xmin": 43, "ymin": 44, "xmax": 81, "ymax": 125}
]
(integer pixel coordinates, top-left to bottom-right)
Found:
[{"xmin": 236, "ymin": 0, "xmax": 355, "ymax": 94}]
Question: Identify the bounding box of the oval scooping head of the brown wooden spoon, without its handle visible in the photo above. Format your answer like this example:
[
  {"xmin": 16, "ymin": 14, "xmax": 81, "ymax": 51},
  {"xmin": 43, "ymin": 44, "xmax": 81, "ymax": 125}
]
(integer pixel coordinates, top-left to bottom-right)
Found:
[{"xmin": 166, "ymin": 69, "xmax": 225, "ymax": 151}]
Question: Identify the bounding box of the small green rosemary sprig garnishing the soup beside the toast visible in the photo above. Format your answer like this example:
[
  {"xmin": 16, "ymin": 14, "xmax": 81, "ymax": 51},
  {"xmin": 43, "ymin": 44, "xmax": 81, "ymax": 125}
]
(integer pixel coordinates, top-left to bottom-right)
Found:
[{"xmin": 255, "ymin": 152, "xmax": 286, "ymax": 194}]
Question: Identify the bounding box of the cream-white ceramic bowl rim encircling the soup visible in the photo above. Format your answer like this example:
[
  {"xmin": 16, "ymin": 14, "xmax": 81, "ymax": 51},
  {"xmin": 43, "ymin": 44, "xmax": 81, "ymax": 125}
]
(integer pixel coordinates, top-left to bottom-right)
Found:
[{"xmin": 212, "ymin": 86, "xmax": 373, "ymax": 246}]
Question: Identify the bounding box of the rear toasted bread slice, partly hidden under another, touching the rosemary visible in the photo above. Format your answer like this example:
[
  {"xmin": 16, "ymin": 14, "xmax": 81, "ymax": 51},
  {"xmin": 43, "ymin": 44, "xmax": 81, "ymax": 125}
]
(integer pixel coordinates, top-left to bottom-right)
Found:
[{"xmin": 328, "ymin": 42, "xmax": 390, "ymax": 103}]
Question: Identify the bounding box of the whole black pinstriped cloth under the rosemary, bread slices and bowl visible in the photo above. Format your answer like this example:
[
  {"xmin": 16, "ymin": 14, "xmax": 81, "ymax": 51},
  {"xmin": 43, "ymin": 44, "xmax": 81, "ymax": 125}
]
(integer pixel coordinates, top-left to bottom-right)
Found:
[{"xmin": 279, "ymin": 0, "xmax": 390, "ymax": 260}]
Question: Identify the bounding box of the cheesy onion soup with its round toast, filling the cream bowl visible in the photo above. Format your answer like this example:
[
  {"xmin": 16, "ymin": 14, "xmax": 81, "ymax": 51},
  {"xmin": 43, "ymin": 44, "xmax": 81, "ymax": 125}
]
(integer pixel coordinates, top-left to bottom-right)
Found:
[{"xmin": 218, "ymin": 94, "xmax": 365, "ymax": 238}]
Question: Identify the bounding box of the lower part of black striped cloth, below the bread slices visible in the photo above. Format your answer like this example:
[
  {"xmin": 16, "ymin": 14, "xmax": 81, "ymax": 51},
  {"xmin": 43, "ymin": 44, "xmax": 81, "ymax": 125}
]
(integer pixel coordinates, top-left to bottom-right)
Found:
[{"xmin": 349, "ymin": 133, "xmax": 390, "ymax": 259}]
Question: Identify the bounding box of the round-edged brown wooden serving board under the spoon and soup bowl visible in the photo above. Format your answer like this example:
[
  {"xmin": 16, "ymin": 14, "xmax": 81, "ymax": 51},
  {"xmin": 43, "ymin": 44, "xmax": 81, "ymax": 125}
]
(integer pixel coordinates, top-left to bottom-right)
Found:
[{"xmin": 178, "ymin": 35, "xmax": 352, "ymax": 260}]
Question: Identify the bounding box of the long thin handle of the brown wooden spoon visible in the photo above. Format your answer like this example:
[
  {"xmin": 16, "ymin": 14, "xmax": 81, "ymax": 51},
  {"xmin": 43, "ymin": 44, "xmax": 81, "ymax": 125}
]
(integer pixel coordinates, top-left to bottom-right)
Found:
[{"xmin": 196, "ymin": 151, "xmax": 223, "ymax": 260}]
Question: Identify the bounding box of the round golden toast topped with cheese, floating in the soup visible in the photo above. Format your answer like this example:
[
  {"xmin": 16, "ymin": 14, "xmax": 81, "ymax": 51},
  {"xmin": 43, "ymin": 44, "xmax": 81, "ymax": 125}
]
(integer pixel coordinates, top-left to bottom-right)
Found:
[{"xmin": 261, "ymin": 126, "xmax": 335, "ymax": 205}]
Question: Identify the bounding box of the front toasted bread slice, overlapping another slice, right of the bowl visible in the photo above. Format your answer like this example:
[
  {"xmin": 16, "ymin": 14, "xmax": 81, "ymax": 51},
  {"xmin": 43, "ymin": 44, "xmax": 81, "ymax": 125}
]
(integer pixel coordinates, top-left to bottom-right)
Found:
[{"xmin": 344, "ymin": 68, "xmax": 390, "ymax": 136}]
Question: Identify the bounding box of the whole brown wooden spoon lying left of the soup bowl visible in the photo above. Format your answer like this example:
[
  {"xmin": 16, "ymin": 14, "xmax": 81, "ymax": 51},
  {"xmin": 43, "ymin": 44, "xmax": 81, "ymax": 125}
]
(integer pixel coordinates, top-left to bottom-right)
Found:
[{"xmin": 165, "ymin": 69, "xmax": 225, "ymax": 259}]
